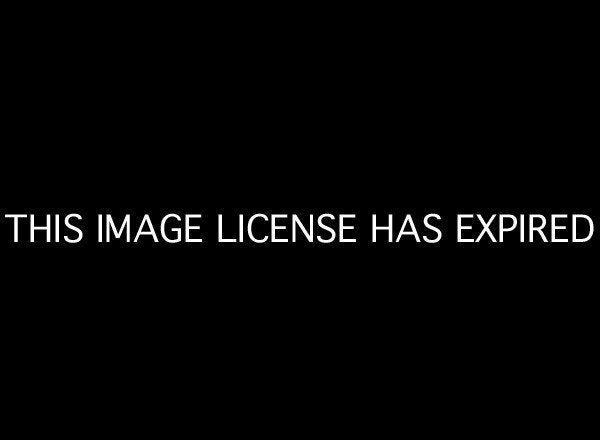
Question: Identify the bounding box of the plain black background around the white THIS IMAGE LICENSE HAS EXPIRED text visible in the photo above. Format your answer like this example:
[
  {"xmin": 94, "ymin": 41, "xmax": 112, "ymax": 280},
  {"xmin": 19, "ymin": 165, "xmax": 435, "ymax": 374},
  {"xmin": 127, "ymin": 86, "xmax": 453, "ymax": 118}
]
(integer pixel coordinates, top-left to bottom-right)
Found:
[{"xmin": 1, "ymin": 5, "xmax": 598, "ymax": 433}]
